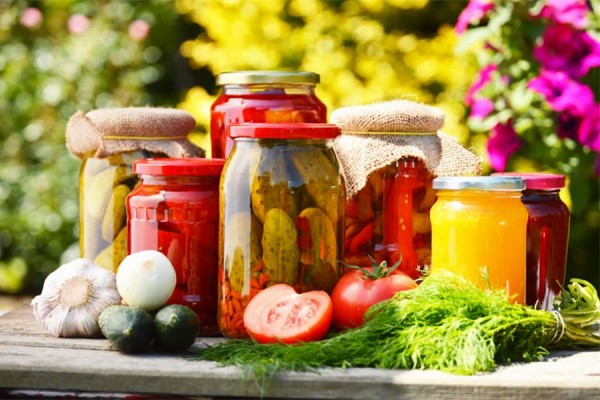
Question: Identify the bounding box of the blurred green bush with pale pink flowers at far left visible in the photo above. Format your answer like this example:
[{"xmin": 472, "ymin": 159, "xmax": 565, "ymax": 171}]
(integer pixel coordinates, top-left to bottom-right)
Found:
[{"xmin": 0, "ymin": 0, "xmax": 188, "ymax": 293}]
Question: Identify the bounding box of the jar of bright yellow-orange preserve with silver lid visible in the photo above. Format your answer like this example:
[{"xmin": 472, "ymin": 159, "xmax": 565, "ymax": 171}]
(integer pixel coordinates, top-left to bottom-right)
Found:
[{"xmin": 431, "ymin": 176, "xmax": 527, "ymax": 304}]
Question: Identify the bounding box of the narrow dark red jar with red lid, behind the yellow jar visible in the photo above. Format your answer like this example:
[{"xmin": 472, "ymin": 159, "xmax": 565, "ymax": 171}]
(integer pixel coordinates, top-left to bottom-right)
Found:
[{"xmin": 493, "ymin": 172, "xmax": 570, "ymax": 310}]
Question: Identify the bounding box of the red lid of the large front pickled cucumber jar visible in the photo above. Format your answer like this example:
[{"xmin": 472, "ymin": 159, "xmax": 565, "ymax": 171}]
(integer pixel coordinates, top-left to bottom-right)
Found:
[{"xmin": 229, "ymin": 123, "xmax": 341, "ymax": 139}]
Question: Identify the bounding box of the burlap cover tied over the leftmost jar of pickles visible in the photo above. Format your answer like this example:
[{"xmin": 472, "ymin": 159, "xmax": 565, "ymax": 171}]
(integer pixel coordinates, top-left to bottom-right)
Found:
[{"xmin": 66, "ymin": 107, "xmax": 204, "ymax": 158}]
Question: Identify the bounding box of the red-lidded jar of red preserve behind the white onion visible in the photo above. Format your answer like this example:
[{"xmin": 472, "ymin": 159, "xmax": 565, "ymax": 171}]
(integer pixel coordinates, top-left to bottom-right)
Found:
[{"xmin": 127, "ymin": 158, "xmax": 225, "ymax": 336}]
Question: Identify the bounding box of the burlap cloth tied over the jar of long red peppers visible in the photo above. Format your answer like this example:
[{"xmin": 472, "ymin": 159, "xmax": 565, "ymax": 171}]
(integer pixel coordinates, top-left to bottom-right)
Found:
[{"xmin": 331, "ymin": 100, "xmax": 481, "ymax": 197}]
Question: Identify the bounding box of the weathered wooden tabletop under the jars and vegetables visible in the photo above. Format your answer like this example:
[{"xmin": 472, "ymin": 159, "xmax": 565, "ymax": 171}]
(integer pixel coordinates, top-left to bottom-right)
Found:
[{"xmin": 0, "ymin": 305, "xmax": 600, "ymax": 400}]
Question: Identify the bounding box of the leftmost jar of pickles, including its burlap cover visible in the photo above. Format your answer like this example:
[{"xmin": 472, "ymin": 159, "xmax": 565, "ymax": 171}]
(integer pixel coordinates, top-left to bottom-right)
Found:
[{"xmin": 66, "ymin": 107, "xmax": 203, "ymax": 271}]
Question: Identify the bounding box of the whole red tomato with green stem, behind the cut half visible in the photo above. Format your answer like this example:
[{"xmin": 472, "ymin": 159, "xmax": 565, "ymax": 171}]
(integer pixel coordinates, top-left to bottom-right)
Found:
[{"xmin": 331, "ymin": 262, "xmax": 417, "ymax": 331}]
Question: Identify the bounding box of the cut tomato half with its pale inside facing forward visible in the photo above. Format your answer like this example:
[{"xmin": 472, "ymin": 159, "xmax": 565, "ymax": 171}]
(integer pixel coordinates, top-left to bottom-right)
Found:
[{"xmin": 244, "ymin": 284, "xmax": 333, "ymax": 344}]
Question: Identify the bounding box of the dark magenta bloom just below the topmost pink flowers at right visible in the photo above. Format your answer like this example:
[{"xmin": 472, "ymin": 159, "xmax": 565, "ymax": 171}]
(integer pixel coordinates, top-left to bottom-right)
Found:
[{"xmin": 533, "ymin": 25, "xmax": 600, "ymax": 78}]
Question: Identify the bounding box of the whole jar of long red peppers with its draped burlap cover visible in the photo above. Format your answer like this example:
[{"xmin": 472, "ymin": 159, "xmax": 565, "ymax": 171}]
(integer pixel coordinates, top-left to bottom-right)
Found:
[{"xmin": 331, "ymin": 100, "xmax": 481, "ymax": 277}]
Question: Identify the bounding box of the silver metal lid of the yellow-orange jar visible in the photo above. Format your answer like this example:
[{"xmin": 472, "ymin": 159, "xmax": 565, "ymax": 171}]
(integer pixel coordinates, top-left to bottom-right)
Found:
[{"xmin": 433, "ymin": 176, "xmax": 525, "ymax": 192}]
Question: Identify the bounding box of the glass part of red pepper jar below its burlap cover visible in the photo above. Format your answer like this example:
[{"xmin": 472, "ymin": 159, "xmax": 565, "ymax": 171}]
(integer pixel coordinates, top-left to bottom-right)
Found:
[{"xmin": 344, "ymin": 157, "xmax": 435, "ymax": 278}]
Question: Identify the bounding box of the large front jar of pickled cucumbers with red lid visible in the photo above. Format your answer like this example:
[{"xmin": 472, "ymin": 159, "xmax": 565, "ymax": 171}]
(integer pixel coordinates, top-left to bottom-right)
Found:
[{"xmin": 218, "ymin": 123, "xmax": 345, "ymax": 338}]
